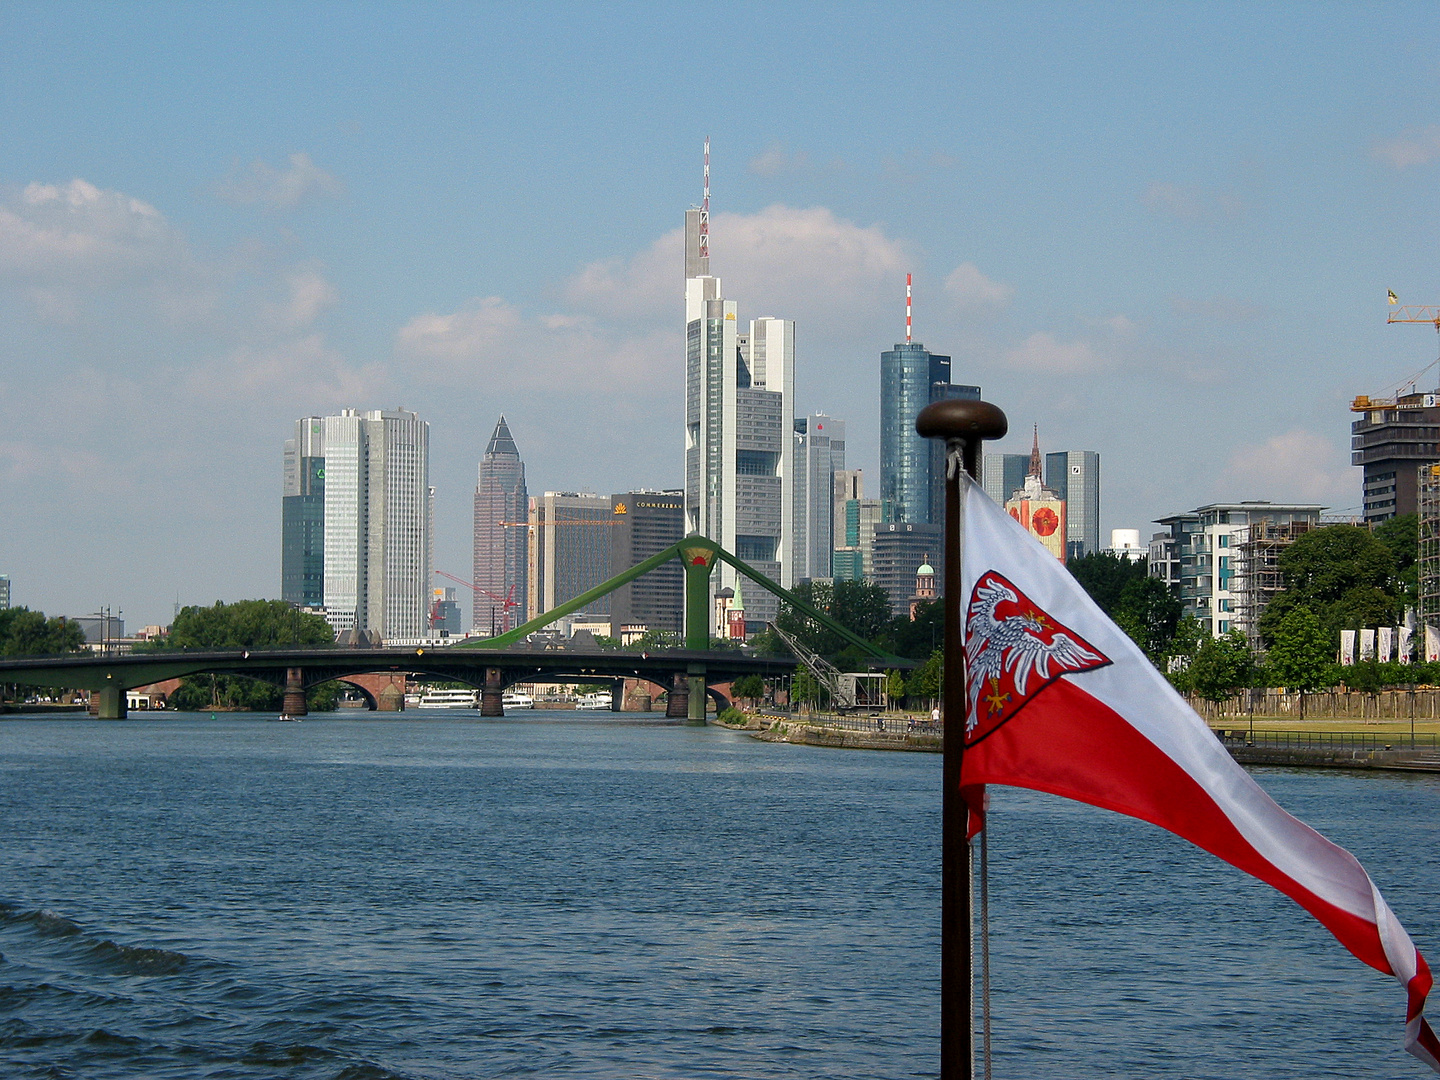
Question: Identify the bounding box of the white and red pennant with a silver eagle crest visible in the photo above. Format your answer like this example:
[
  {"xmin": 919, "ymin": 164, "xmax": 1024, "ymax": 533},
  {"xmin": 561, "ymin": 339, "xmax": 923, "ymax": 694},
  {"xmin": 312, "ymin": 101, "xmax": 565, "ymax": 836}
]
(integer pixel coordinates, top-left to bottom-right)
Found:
[{"xmin": 962, "ymin": 478, "xmax": 1440, "ymax": 1071}]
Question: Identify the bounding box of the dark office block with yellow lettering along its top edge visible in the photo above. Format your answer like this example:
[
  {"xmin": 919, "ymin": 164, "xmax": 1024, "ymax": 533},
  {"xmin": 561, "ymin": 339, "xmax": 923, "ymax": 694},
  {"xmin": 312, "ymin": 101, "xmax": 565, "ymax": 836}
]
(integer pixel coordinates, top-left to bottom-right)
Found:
[{"xmin": 609, "ymin": 491, "xmax": 685, "ymax": 638}]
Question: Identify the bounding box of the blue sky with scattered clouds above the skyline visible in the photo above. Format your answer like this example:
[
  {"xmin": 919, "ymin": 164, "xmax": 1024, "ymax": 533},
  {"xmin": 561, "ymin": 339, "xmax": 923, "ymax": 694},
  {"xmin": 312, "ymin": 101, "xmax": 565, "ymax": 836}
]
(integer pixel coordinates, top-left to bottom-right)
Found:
[{"xmin": 0, "ymin": 1, "xmax": 1440, "ymax": 625}]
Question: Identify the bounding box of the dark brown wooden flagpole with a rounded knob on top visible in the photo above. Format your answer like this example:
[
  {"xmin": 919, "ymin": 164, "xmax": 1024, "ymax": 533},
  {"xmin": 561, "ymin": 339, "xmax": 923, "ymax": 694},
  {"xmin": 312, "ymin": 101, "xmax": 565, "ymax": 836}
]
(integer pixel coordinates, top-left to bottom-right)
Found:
[{"xmin": 914, "ymin": 399, "xmax": 1009, "ymax": 1080}]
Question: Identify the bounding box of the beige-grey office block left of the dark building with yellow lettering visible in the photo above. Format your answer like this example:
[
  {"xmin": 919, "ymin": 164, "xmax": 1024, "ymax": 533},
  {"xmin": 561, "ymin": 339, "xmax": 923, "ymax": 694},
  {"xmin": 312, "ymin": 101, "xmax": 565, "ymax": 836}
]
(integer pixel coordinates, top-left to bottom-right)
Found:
[{"xmin": 527, "ymin": 491, "xmax": 613, "ymax": 619}]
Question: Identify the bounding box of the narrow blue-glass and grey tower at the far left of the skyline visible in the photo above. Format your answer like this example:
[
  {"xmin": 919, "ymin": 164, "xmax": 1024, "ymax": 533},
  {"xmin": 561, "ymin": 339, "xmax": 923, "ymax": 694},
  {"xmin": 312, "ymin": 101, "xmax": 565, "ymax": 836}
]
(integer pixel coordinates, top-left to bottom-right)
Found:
[{"xmin": 279, "ymin": 416, "xmax": 325, "ymax": 608}]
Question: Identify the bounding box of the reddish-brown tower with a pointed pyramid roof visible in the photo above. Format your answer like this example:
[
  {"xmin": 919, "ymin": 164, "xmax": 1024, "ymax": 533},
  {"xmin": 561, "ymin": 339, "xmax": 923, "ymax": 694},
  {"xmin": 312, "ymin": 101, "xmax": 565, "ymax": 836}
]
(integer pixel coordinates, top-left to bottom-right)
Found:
[{"xmin": 471, "ymin": 416, "xmax": 530, "ymax": 634}]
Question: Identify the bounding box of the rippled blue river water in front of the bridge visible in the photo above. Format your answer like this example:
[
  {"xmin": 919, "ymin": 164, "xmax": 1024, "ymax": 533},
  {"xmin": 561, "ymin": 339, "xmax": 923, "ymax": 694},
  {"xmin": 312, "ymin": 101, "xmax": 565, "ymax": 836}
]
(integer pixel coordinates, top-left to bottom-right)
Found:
[{"xmin": 0, "ymin": 713, "xmax": 1440, "ymax": 1080}]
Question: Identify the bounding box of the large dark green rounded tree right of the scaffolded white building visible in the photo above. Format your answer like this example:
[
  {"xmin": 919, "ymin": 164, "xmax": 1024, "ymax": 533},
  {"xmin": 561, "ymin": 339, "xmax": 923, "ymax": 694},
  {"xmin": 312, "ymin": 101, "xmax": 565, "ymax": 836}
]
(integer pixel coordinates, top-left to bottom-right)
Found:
[{"xmin": 1260, "ymin": 526, "xmax": 1404, "ymax": 645}]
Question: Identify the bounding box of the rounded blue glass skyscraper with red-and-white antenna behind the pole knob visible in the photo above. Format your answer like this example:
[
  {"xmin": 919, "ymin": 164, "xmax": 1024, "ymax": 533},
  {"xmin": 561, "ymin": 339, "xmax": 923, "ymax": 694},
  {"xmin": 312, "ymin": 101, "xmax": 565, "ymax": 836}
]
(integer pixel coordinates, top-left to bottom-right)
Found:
[{"xmin": 880, "ymin": 274, "xmax": 981, "ymax": 527}]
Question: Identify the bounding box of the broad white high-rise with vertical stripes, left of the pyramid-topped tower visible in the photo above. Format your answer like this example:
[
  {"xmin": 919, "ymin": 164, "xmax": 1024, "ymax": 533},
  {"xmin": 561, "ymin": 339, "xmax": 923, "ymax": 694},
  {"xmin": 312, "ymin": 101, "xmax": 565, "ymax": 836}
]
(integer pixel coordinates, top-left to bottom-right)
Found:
[{"xmin": 315, "ymin": 409, "xmax": 432, "ymax": 639}]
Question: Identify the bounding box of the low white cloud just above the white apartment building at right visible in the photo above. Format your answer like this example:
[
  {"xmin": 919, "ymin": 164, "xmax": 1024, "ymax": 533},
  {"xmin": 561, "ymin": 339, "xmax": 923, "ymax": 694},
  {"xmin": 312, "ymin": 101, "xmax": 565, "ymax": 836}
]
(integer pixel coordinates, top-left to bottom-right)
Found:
[{"xmin": 1215, "ymin": 428, "xmax": 1356, "ymax": 507}]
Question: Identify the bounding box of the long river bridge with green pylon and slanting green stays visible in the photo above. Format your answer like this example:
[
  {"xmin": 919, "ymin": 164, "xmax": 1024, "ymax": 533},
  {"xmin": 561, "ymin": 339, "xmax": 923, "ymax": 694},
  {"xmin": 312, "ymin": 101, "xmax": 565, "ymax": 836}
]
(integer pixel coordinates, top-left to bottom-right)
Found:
[{"xmin": 0, "ymin": 536, "xmax": 914, "ymax": 723}]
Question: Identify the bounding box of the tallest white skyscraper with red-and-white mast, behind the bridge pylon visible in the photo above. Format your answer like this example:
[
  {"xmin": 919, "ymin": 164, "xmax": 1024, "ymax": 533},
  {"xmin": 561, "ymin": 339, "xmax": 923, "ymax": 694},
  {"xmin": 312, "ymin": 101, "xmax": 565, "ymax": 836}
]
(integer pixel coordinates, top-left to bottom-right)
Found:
[{"xmin": 685, "ymin": 140, "xmax": 796, "ymax": 629}]
